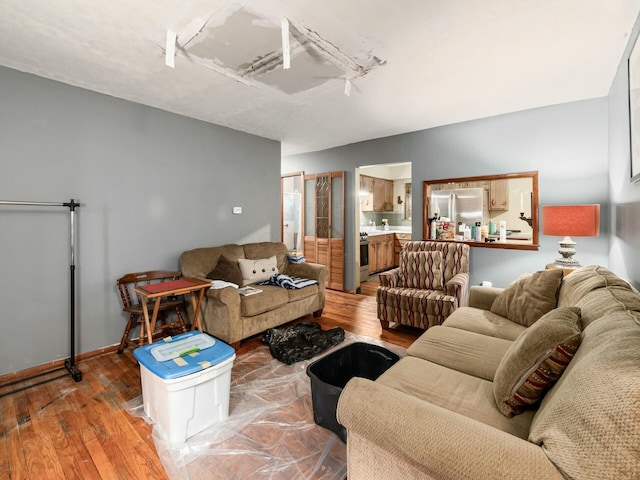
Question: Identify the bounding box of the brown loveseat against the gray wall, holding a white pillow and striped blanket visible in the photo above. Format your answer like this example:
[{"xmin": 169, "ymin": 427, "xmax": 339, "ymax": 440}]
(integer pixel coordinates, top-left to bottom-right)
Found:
[{"xmin": 180, "ymin": 242, "xmax": 328, "ymax": 347}]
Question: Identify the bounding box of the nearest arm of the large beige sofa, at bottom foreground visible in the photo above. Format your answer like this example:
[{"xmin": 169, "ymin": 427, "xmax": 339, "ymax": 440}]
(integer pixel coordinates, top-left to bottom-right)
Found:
[{"xmin": 337, "ymin": 378, "xmax": 563, "ymax": 480}]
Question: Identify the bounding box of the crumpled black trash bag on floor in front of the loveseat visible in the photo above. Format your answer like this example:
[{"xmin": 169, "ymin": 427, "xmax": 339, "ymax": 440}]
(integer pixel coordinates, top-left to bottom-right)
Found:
[{"xmin": 262, "ymin": 322, "xmax": 344, "ymax": 365}]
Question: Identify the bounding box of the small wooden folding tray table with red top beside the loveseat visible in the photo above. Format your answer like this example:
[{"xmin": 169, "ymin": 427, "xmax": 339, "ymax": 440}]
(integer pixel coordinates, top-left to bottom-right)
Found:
[{"xmin": 133, "ymin": 278, "xmax": 211, "ymax": 343}]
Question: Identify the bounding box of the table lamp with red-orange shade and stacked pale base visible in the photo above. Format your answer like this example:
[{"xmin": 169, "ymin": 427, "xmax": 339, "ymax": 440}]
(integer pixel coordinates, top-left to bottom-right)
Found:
[{"xmin": 542, "ymin": 204, "xmax": 600, "ymax": 268}]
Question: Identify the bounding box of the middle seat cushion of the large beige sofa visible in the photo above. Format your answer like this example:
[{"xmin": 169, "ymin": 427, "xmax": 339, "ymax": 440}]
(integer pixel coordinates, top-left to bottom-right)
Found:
[{"xmin": 407, "ymin": 325, "xmax": 512, "ymax": 381}]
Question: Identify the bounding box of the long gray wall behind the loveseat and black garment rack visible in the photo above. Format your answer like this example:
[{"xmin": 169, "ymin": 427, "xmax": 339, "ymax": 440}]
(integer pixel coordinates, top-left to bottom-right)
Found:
[{"xmin": 0, "ymin": 68, "xmax": 280, "ymax": 374}]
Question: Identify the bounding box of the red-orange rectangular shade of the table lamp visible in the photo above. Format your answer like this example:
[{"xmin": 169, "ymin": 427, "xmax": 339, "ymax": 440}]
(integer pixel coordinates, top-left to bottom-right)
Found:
[{"xmin": 542, "ymin": 204, "xmax": 600, "ymax": 237}]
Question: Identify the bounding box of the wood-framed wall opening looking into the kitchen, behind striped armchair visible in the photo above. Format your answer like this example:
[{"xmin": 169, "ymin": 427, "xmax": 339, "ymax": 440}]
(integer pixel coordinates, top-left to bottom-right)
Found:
[{"xmin": 422, "ymin": 172, "xmax": 540, "ymax": 250}]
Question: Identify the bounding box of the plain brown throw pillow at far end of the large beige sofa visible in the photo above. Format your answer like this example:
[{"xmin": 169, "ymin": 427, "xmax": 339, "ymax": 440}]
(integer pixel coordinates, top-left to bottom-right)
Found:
[{"xmin": 491, "ymin": 269, "xmax": 562, "ymax": 327}]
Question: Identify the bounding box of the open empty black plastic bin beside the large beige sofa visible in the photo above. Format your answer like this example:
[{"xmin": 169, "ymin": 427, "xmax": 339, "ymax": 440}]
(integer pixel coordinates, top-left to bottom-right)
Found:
[{"xmin": 307, "ymin": 342, "xmax": 400, "ymax": 442}]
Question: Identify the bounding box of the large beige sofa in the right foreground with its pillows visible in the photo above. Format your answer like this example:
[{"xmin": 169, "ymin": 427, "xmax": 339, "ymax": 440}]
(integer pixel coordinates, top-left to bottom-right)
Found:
[{"xmin": 337, "ymin": 266, "xmax": 640, "ymax": 480}]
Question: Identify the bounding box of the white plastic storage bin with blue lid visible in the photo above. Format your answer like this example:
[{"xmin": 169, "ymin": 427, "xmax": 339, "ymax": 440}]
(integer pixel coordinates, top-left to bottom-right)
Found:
[{"xmin": 133, "ymin": 331, "xmax": 235, "ymax": 443}]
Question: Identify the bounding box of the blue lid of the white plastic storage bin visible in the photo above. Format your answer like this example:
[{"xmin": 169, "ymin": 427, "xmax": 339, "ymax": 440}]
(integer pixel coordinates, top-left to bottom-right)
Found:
[{"xmin": 133, "ymin": 331, "xmax": 236, "ymax": 380}]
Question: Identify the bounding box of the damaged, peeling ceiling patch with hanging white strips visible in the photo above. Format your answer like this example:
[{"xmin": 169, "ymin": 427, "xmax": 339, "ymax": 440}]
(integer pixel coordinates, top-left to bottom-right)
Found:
[{"xmin": 166, "ymin": 7, "xmax": 384, "ymax": 94}]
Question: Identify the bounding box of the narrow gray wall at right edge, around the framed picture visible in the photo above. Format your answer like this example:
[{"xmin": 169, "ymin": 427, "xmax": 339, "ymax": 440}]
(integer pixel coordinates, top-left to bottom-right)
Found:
[{"xmin": 609, "ymin": 15, "xmax": 640, "ymax": 288}]
